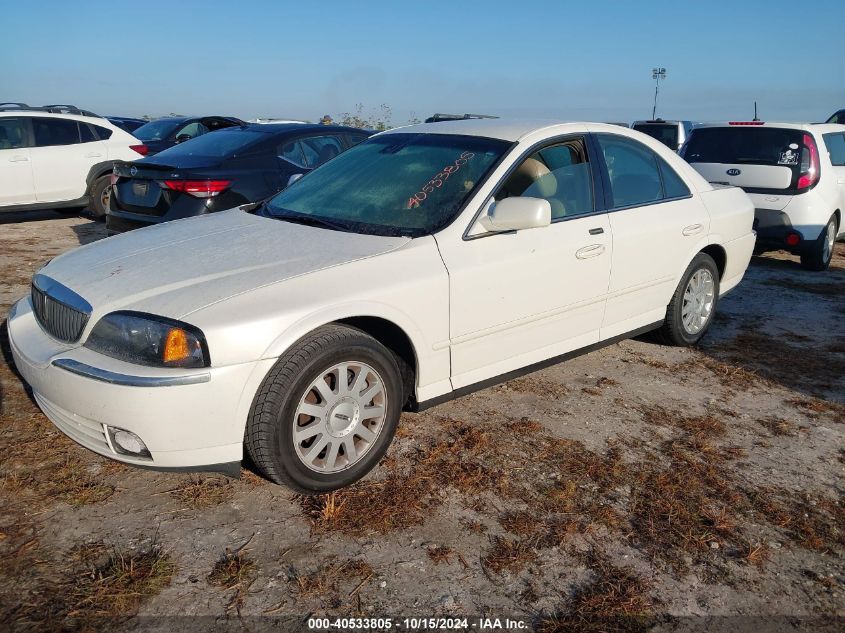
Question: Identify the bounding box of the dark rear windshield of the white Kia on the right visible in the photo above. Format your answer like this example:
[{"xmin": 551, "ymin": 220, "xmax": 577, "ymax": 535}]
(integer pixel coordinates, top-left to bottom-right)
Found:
[{"xmin": 682, "ymin": 127, "xmax": 804, "ymax": 169}]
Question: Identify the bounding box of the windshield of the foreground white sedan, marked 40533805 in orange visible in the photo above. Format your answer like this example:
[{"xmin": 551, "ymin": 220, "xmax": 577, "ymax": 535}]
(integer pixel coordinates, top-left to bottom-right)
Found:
[{"xmin": 265, "ymin": 133, "xmax": 510, "ymax": 236}]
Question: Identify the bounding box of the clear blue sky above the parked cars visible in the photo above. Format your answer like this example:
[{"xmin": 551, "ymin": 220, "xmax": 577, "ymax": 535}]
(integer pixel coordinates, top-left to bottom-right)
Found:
[{"xmin": 0, "ymin": 0, "xmax": 845, "ymax": 125}]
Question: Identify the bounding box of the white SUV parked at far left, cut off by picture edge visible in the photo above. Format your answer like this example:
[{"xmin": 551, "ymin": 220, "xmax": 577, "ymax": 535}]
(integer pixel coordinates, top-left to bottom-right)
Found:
[{"xmin": 0, "ymin": 104, "xmax": 146, "ymax": 218}]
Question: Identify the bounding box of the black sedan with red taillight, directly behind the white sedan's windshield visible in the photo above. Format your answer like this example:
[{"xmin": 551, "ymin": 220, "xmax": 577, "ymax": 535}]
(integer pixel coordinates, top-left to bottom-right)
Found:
[{"xmin": 106, "ymin": 123, "xmax": 372, "ymax": 234}]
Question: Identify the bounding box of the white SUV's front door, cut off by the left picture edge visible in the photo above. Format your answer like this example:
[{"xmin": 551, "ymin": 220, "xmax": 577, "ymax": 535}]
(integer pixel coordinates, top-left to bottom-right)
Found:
[{"xmin": 0, "ymin": 117, "xmax": 35, "ymax": 207}]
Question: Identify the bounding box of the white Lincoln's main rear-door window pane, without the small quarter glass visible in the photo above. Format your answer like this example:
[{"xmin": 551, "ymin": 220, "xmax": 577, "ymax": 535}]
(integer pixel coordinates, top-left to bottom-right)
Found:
[{"xmin": 597, "ymin": 134, "xmax": 663, "ymax": 209}]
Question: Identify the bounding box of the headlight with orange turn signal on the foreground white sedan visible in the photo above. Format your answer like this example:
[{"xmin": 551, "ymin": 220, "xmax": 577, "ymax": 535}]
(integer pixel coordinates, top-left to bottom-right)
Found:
[{"xmin": 85, "ymin": 311, "xmax": 211, "ymax": 367}]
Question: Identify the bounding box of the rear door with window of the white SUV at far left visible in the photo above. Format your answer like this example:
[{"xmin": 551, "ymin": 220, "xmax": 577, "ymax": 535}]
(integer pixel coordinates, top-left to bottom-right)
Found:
[{"xmin": 31, "ymin": 117, "xmax": 107, "ymax": 202}]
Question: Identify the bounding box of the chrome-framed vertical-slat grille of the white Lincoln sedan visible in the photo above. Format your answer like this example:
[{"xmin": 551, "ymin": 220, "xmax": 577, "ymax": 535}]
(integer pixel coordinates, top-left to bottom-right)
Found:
[{"xmin": 31, "ymin": 275, "xmax": 91, "ymax": 343}]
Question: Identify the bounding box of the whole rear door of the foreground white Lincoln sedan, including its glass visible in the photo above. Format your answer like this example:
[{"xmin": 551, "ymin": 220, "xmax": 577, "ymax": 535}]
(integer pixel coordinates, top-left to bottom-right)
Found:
[{"xmin": 595, "ymin": 134, "xmax": 710, "ymax": 340}]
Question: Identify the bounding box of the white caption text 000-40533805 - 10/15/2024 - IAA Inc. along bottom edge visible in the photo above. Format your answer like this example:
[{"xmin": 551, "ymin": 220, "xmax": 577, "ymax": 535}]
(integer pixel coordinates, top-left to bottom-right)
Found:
[{"xmin": 308, "ymin": 617, "xmax": 528, "ymax": 631}]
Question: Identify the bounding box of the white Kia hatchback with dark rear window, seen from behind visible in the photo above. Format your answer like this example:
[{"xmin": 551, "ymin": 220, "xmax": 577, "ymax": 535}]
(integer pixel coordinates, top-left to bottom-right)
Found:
[{"xmin": 681, "ymin": 121, "xmax": 845, "ymax": 270}]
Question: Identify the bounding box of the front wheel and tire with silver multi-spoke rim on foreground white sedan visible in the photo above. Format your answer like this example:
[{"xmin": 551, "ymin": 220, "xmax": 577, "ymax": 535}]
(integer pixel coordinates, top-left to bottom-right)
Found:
[{"xmin": 244, "ymin": 325, "xmax": 405, "ymax": 494}]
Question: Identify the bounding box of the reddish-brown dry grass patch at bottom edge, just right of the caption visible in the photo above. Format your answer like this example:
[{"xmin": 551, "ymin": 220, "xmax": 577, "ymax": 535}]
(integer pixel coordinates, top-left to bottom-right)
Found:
[{"xmin": 537, "ymin": 551, "xmax": 654, "ymax": 633}]
